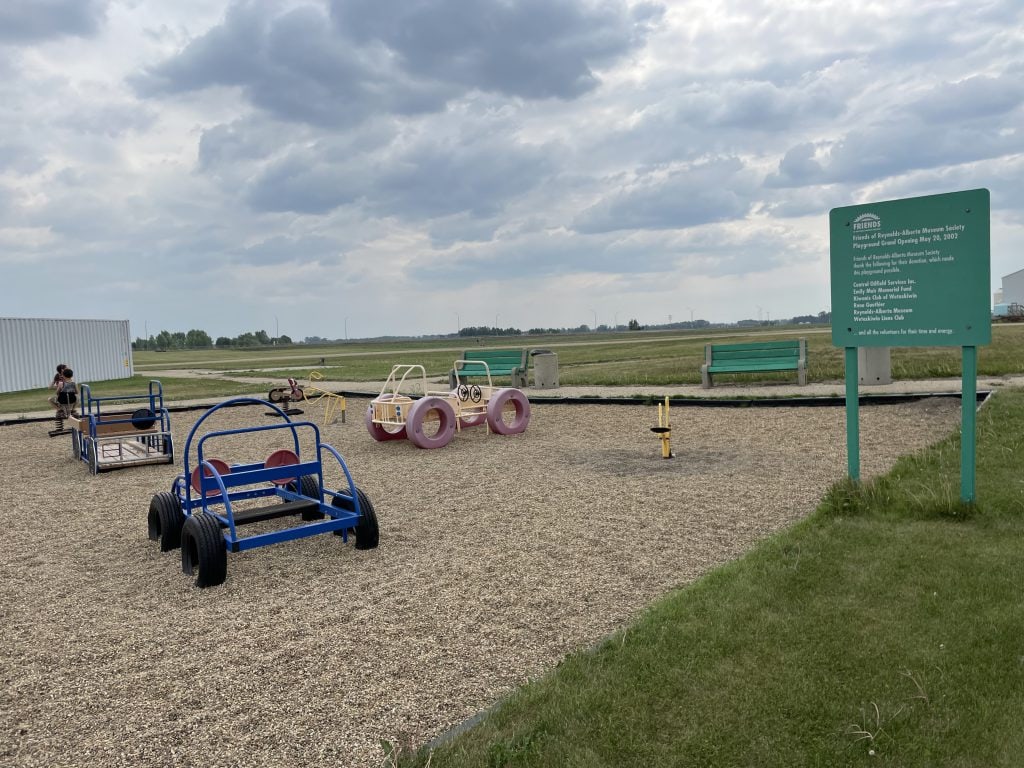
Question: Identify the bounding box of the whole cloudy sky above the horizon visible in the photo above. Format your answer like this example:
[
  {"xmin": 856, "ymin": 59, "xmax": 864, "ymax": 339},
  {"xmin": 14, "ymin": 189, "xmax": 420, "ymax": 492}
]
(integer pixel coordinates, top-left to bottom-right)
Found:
[{"xmin": 0, "ymin": 0, "xmax": 1024, "ymax": 339}]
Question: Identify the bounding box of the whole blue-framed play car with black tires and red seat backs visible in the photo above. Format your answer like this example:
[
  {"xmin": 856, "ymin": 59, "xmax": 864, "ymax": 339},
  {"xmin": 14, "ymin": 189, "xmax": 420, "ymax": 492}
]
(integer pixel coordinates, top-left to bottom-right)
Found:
[{"xmin": 147, "ymin": 397, "xmax": 380, "ymax": 587}]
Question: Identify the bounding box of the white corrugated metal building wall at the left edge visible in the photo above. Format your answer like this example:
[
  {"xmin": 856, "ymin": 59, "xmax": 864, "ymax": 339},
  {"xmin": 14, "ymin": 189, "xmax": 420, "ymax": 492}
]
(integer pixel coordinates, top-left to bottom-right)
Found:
[{"xmin": 0, "ymin": 317, "xmax": 135, "ymax": 392}]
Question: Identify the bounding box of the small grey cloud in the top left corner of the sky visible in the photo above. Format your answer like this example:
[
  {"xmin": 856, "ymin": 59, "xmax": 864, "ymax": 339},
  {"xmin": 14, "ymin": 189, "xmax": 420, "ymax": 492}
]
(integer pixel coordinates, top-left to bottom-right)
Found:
[{"xmin": 0, "ymin": 0, "xmax": 109, "ymax": 45}]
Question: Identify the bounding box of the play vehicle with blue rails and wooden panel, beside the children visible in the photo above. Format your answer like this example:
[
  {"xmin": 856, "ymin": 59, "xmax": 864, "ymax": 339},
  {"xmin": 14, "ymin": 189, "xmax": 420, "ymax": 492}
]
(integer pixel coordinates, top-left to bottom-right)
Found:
[{"xmin": 69, "ymin": 381, "xmax": 174, "ymax": 474}]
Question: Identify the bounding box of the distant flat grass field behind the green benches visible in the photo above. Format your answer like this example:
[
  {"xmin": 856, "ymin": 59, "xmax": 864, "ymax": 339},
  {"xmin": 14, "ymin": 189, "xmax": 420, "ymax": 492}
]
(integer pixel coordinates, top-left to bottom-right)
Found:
[{"xmin": 6, "ymin": 324, "xmax": 1024, "ymax": 413}]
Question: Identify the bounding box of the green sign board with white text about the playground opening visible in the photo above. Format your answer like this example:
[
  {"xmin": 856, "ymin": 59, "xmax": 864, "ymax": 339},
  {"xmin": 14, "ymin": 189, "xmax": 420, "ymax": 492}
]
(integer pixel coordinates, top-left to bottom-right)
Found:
[{"xmin": 828, "ymin": 189, "xmax": 992, "ymax": 347}]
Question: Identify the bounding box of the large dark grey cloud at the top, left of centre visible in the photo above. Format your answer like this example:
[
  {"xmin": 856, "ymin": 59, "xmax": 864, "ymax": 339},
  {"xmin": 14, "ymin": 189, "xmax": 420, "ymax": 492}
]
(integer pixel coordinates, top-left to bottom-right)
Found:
[{"xmin": 132, "ymin": 0, "xmax": 659, "ymax": 128}]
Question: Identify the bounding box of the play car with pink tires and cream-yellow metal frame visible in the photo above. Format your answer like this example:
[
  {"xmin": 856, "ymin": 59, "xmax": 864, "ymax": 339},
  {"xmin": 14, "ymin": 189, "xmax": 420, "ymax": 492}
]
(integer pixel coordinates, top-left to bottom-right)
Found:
[{"xmin": 366, "ymin": 360, "xmax": 529, "ymax": 449}]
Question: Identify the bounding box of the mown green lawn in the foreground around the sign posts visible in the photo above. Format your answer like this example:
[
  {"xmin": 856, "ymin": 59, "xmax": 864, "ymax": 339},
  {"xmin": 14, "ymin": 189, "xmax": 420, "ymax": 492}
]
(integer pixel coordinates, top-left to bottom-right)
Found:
[{"xmin": 394, "ymin": 391, "xmax": 1024, "ymax": 768}]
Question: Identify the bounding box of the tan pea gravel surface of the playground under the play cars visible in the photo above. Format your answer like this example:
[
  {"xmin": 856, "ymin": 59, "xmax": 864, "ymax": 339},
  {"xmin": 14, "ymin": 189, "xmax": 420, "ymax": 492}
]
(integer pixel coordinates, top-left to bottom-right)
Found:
[{"xmin": 0, "ymin": 398, "xmax": 959, "ymax": 767}]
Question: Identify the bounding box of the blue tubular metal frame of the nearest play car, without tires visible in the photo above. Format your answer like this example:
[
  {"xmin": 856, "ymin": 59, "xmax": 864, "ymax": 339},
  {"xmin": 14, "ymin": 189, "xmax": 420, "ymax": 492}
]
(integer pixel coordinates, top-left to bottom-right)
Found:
[{"xmin": 171, "ymin": 397, "xmax": 362, "ymax": 552}]
